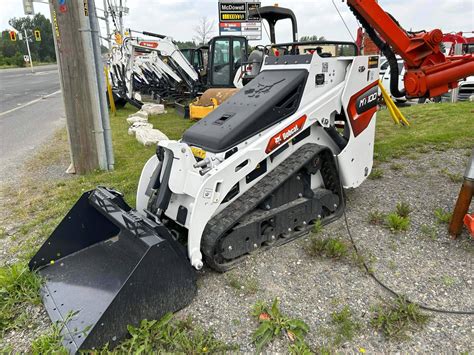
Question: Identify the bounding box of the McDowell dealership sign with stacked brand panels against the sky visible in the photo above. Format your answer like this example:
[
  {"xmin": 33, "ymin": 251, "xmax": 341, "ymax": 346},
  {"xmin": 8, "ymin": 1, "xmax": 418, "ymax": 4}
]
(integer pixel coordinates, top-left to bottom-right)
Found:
[{"xmin": 218, "ymin": 0, "xmax": 262, "ymax": 40}]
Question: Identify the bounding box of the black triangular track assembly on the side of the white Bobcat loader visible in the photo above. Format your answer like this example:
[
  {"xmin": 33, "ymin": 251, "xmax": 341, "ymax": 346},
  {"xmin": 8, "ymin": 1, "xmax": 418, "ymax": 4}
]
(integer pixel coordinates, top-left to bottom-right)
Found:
[{"xmin": 202, "ymin": 144, "xmax": 344, "ymax": 272}]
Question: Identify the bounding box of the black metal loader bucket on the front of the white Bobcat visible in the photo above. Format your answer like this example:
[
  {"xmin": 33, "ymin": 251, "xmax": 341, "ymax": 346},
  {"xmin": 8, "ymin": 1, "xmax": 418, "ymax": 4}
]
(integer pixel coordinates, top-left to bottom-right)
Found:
[{"xmin": 29, "ymin": 187, "xmax": 197, "ymax": 352}]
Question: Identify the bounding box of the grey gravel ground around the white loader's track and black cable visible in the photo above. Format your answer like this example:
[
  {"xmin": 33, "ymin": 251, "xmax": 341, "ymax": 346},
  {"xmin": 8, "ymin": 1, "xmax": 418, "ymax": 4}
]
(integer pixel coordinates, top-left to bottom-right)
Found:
[{"xmin": 0, "ymin": 150, "xmax": 474, "ymax": 353}]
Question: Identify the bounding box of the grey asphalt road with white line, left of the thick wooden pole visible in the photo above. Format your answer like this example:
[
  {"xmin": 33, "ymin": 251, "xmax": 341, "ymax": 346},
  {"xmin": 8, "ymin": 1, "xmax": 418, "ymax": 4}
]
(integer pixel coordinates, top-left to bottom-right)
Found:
[{"xmin": 0, "ymin": 65, "xmax": 65, "ymax": 182}]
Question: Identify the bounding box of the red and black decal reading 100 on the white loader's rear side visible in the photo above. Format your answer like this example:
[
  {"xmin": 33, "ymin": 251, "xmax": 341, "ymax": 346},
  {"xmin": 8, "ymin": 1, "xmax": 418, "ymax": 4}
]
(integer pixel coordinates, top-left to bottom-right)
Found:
[{"xmin": 347, "ymin": 81, "xmax": 378, "ymax": 137}]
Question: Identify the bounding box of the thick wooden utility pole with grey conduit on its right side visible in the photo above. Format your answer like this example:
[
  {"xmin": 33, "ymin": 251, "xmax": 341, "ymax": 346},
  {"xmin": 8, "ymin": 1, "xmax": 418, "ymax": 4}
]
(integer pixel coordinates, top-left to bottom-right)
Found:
[{"xmin": 50, "ymin": 0, "xmax": 113, "ymax": 174}]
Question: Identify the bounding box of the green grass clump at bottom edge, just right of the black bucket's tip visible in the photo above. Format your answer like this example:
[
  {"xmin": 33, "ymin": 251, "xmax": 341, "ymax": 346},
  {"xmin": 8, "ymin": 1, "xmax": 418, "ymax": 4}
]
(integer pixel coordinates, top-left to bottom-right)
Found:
[{"xmin": 111, "ymin": 313, "xmax": 237, "ymax": 354}]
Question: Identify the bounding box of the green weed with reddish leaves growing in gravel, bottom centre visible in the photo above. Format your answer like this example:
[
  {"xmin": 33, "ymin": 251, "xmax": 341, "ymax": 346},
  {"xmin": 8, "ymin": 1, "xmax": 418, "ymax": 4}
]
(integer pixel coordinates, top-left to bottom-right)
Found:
[{"xmin": 252, "ymin": 298, "xmax": 310, "ymax": 354}]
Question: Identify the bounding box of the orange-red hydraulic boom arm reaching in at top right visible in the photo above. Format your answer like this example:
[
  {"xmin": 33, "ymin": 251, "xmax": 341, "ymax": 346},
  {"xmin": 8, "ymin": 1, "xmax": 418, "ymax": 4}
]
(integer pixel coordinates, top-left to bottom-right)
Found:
[{"xmin": 347, "ymin": 0, "xmax": 474, "ymax": 97}]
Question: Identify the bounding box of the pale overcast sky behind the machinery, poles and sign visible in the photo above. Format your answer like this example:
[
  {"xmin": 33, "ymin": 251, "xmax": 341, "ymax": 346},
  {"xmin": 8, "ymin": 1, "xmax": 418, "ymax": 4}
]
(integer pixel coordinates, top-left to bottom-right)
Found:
[{"xmin": 0, "ymin": 0, "xmax": 474, "ymax": 44}]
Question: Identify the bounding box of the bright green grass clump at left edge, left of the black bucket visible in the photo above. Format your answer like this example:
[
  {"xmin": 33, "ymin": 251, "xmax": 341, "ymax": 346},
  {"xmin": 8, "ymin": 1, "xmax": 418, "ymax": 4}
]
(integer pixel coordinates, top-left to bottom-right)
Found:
[{"xmin": 0, "ymin": 263, "xmax": 41, "ymax": 335}]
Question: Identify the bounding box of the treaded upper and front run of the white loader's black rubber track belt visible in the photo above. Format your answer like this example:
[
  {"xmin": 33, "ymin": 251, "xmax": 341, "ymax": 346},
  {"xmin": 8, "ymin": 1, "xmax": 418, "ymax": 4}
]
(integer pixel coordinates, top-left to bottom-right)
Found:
[{"xmin": 201, "ymin": 143, "xmax": 325, "ymax": 270}]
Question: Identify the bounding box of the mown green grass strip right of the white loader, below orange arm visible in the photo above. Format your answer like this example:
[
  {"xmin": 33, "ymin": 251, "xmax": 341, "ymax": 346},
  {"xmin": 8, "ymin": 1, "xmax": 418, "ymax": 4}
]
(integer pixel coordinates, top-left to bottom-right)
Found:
[{"xmin": 375, "ymin": 102, "xmax": 474, "ymax": 161}]
